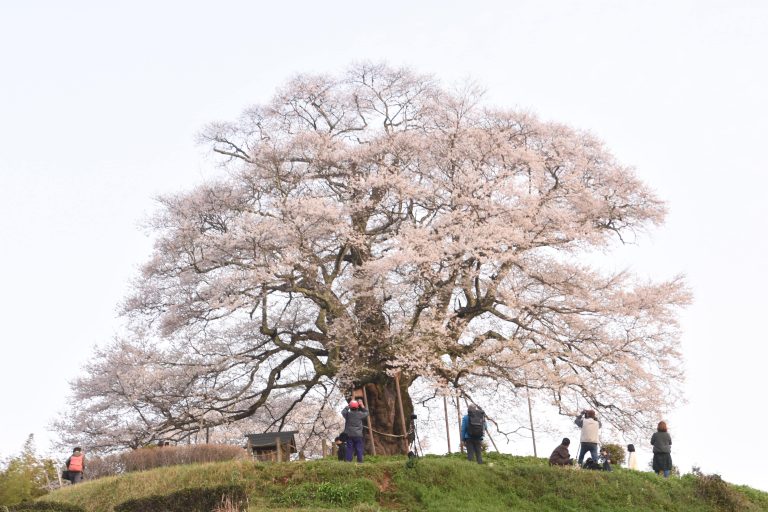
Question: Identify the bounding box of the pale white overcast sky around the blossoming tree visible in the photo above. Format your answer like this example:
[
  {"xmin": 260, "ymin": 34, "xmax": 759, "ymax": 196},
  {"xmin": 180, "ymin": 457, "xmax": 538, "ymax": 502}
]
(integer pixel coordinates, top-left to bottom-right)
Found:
[{"xmin": 0, "ymin": 0, "xmax": 768, "ymax": 491}]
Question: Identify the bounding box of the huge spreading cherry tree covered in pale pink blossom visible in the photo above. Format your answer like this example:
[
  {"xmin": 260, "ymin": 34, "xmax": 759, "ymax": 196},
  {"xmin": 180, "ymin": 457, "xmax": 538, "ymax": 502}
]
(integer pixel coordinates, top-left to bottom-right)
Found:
[{"xmin": 57, "ymin": 64, "xmax": 690, "ymax": 453}]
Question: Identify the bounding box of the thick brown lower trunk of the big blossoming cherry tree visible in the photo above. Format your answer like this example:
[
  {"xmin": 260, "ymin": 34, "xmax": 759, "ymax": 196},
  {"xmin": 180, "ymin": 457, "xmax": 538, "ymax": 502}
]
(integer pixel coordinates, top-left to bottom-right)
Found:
[{"xmin": 364, "ymin": 375, "xmax": 413, "ymax": 455}]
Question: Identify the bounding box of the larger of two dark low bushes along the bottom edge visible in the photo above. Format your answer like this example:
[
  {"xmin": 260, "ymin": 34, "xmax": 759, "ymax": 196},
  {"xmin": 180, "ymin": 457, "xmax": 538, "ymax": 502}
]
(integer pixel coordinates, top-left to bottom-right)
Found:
[{"xmin": 115, "ymin": 485, "xmax": 248, "ymax": 512}]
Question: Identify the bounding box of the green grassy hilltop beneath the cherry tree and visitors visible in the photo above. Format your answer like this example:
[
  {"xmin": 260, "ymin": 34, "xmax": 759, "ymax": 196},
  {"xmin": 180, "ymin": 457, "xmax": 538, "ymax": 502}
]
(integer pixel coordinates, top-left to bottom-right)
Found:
[{"xmin": 37, "ymin": 453, "xmax": 768, "ymax": 512}]
